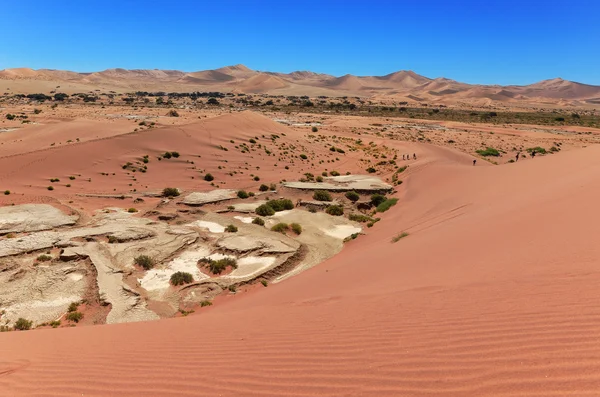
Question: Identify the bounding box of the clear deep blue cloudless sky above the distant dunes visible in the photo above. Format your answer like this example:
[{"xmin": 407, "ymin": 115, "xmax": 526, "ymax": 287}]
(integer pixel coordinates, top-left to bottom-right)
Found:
[{"xmin": 0, "ymin": 0, "xmax": 600, "ymax": 85}]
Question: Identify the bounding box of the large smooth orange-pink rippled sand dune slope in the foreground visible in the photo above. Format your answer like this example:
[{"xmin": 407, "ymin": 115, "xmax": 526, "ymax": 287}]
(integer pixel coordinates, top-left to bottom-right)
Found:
[{"xmin": 0, "ymin": 147, "xmax": 600, "ymax": 396}]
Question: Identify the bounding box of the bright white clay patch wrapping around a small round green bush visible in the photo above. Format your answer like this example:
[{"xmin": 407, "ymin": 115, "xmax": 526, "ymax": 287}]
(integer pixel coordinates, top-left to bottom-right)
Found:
[{"xmin": 138, "ymin": 248, "xmax": 212, "ymax": 291}]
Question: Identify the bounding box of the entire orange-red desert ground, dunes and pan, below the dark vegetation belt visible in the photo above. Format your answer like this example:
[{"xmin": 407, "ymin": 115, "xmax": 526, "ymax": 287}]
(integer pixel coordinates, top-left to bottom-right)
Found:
[{"xmin": 0, "ymin": 98, "xmax": 600, "ymax": 397}]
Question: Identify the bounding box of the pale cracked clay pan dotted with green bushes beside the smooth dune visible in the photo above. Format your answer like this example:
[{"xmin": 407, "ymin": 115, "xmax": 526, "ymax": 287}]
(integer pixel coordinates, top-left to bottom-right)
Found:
[{"xmin": 0, "ymin": 175, "xmax": 392, "ymax": 330}]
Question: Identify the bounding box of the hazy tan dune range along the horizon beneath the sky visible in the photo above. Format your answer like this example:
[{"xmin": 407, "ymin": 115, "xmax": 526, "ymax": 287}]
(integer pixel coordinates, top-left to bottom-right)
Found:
[{"xmin": 0, "ymin": 65, "xmax": 600, "ymax": 106}]
